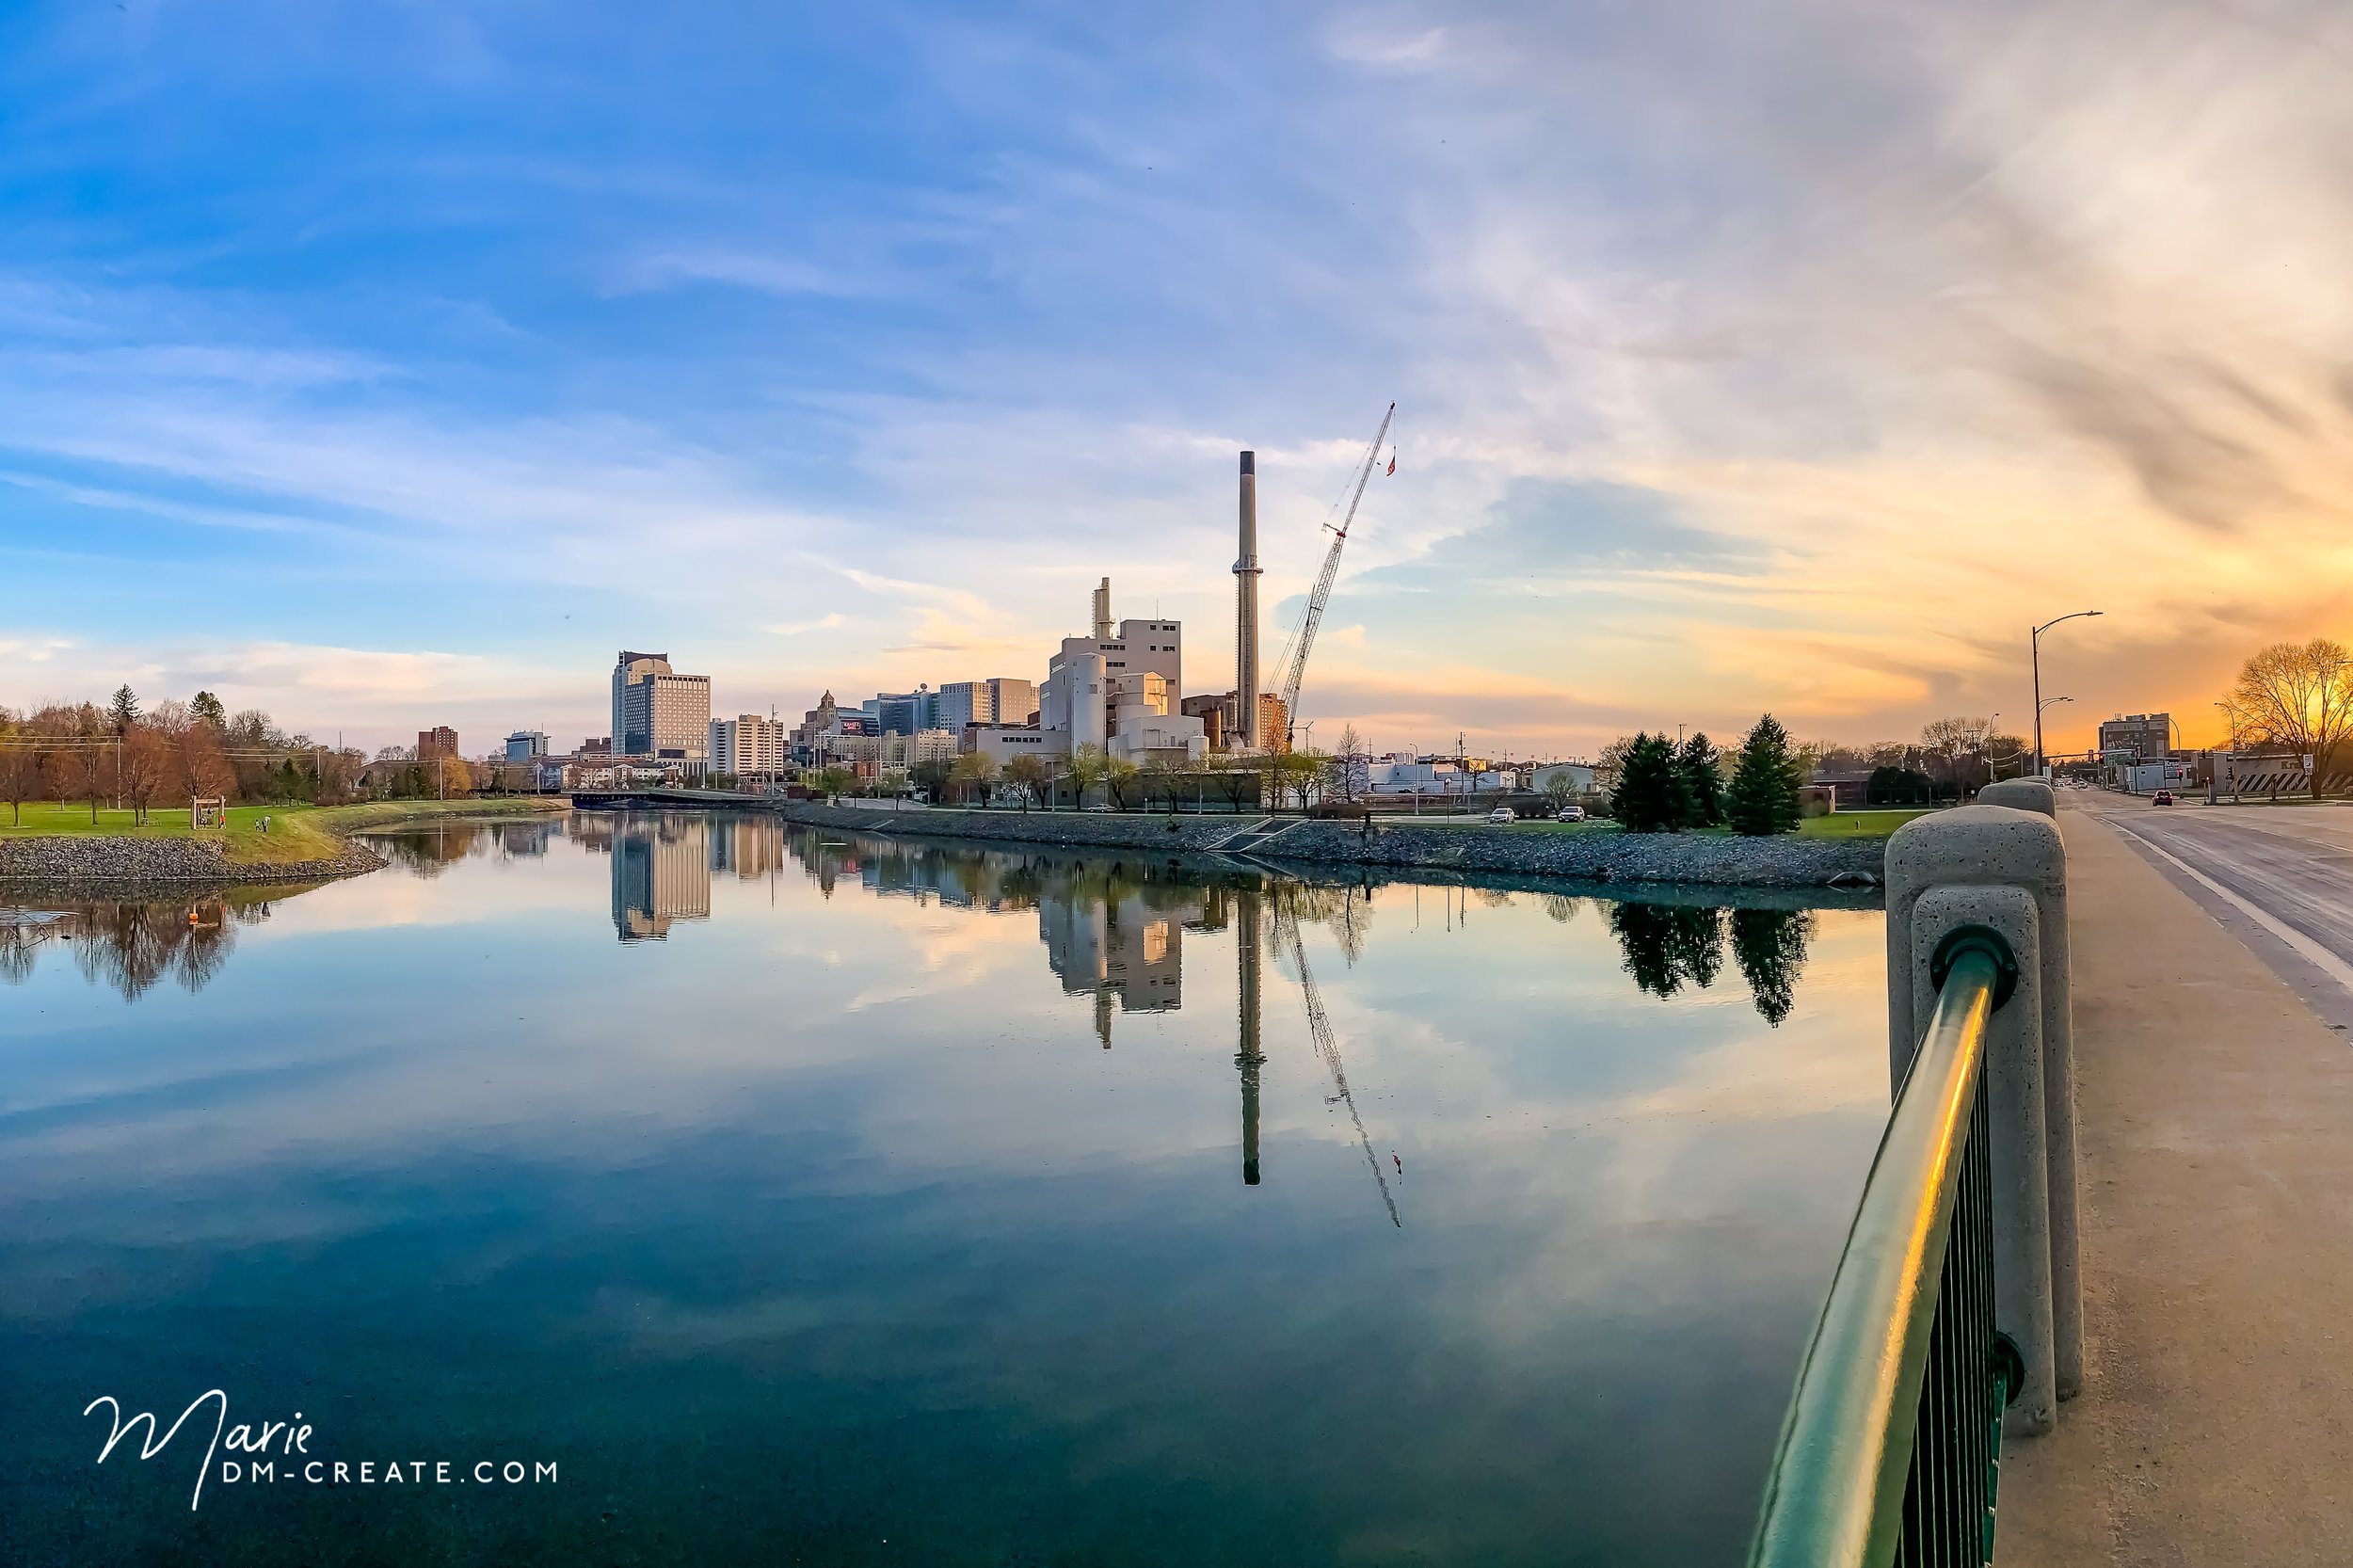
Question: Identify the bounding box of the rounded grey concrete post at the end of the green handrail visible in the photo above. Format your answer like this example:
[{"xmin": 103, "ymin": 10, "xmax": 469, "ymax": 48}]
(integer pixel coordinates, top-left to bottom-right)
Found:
[{"xmin": 1887, "ymin": 800, "xmax": 2083, "ymax": 1433}]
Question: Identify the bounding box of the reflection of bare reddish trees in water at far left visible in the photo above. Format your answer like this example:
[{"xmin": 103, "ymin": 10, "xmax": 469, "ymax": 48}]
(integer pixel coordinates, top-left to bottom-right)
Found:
[{"xmin": 0, "ymin": 895, "xmax": 276, "ymax": 1000}]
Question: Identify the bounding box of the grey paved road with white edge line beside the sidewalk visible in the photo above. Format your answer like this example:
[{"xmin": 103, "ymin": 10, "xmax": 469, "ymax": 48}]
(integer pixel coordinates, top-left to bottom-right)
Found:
[{"xmin": 2059, "ymin": 792, "xmax": 2353, "ymax": 1032}]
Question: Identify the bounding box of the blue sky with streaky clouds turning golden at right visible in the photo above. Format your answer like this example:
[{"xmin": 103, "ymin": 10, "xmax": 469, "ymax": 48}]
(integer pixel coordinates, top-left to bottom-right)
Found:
[{"xmin": 0, "ymin": 0, "xmax": 2353, "ymax": 756}]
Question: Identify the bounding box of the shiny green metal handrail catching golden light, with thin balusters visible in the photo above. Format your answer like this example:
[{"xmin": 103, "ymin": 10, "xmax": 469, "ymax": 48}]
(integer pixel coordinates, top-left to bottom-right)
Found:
[{"xmin": 1749, "ymin": 933, "xmax": 2008, "ymax": 1568}]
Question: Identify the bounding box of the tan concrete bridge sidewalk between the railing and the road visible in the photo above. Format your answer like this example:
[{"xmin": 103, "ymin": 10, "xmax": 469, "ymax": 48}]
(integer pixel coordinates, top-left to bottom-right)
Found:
[{"xmin": 1998, "ymin": 803, "xmax": 2353, "ymax": 1568}]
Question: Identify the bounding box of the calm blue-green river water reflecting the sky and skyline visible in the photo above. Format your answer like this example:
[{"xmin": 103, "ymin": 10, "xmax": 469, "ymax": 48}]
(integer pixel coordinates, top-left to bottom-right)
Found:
[{"xmin": 0, "ymin": 815, "xmax": 1887, "ymax": 1565}]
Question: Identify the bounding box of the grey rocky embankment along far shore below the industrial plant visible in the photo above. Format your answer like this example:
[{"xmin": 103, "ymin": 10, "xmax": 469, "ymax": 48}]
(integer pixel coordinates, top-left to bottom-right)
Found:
[{"xmin": 770, "ymin": 801, "xmax": 1887, "ymax": 888}]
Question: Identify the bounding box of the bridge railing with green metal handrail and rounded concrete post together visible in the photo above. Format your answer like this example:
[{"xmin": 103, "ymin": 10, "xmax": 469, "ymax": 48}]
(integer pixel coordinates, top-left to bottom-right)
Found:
[{"xmin": 1751, "ymin": 784, "xmax": 2083, "ymax": 1568}]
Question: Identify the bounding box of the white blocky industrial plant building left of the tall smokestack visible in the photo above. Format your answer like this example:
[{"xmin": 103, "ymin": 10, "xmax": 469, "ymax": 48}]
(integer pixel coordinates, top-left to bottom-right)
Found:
[{"xmin": 1038, "ymin": 577, "xmax": 1209, "ymax": 762}]
